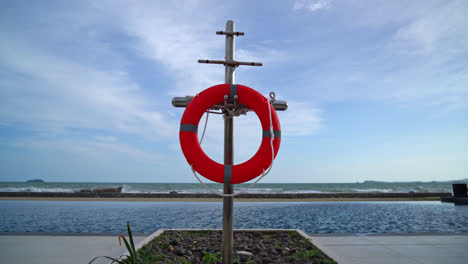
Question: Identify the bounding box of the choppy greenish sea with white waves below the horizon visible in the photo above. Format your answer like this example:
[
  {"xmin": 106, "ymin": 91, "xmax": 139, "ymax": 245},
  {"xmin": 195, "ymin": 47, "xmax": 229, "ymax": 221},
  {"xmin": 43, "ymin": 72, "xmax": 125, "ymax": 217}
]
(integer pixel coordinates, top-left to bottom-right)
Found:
[{"xmin": 0, "ymin": 181, "xmax": 460, "ymax": 193}]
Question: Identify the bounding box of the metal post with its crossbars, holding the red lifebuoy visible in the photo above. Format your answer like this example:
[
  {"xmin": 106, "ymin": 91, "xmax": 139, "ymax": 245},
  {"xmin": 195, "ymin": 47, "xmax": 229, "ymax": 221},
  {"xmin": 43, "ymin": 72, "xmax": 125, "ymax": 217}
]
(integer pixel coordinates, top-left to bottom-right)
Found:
[{"xmin": 172, "ymin": 20, "xmax": 288, "ymax": 264}]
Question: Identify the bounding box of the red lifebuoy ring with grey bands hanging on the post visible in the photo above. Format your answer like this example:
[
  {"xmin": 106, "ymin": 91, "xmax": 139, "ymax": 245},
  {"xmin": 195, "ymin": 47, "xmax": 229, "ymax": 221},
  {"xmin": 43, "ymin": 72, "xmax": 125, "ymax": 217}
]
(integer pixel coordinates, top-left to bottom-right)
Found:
[{"xmin": 179, "ymin": 84, "xmax": 281, "ymax": 184}]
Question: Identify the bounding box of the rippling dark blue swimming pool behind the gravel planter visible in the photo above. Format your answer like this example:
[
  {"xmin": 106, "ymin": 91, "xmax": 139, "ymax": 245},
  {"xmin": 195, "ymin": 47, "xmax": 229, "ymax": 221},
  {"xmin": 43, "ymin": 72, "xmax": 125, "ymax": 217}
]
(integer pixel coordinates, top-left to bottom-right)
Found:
[{"xmin": 0, "ymin": 201, "xmax": 468, "ymax": 234}]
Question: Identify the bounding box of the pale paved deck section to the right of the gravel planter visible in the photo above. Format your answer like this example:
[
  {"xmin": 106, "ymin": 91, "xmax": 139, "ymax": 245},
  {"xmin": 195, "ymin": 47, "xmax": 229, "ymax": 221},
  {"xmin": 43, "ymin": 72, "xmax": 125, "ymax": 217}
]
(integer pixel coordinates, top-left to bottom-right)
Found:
[{"xmin": 309, "ymin": 235, "xmax": 468, "ymax": 264}]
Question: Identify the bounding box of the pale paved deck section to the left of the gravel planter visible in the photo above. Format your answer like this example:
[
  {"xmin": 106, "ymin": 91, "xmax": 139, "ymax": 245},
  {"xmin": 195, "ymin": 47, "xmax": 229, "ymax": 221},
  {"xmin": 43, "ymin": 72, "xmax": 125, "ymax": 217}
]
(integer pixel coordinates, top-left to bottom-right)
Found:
[{"xmin": 0, "ymin": 235, "xmax": 145, "ymax": 264}]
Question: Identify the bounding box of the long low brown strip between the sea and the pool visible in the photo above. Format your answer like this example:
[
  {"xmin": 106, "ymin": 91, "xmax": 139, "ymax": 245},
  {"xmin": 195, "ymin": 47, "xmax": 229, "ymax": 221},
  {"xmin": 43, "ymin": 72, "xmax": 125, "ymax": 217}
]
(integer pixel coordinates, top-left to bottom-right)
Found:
[{"xmin": 0, "ymin": 192, "xmax": 451, "ymax": 199}]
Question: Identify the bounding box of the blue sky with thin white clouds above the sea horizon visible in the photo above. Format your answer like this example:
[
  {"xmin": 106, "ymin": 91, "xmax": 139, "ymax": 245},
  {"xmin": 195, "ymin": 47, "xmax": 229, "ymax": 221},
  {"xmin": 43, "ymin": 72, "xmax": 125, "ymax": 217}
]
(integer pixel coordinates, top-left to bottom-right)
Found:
[{"xmin": 0, "ymin": 0, "xmax": 468, "ymax": 183}]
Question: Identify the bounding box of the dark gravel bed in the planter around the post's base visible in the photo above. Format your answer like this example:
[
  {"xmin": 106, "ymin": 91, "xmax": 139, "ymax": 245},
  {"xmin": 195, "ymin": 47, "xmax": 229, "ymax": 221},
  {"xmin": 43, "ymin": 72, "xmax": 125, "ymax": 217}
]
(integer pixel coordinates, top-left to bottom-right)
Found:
[{"xmin": 138, "ymin": 230, "xmax": 336, "ymax": 264}]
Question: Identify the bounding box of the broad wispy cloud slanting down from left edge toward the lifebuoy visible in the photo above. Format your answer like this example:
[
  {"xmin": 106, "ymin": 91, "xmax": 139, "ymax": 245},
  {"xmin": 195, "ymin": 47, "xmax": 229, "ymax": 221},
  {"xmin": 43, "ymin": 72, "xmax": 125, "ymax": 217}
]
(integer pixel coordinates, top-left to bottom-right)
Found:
[{"xmin": 0, "ymin": 33, "xmax": 176, "ymax": 139}]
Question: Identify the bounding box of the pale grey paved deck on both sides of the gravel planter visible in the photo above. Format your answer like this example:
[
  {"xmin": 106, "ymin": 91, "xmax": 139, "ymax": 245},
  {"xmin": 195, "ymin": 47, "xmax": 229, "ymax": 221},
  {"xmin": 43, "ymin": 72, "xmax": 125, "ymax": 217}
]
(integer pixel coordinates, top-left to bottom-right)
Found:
[{"xmin": 0, "ymin": 235, "xmax": 468, "ymax": 264}]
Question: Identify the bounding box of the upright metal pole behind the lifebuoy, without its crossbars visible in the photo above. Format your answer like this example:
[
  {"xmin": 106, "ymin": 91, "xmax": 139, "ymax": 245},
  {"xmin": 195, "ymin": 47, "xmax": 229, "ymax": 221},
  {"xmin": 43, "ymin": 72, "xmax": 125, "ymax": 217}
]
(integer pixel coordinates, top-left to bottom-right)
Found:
[{"xmin": 223, "ymin": 20, "xmax": 236, "ymax": 264}]
